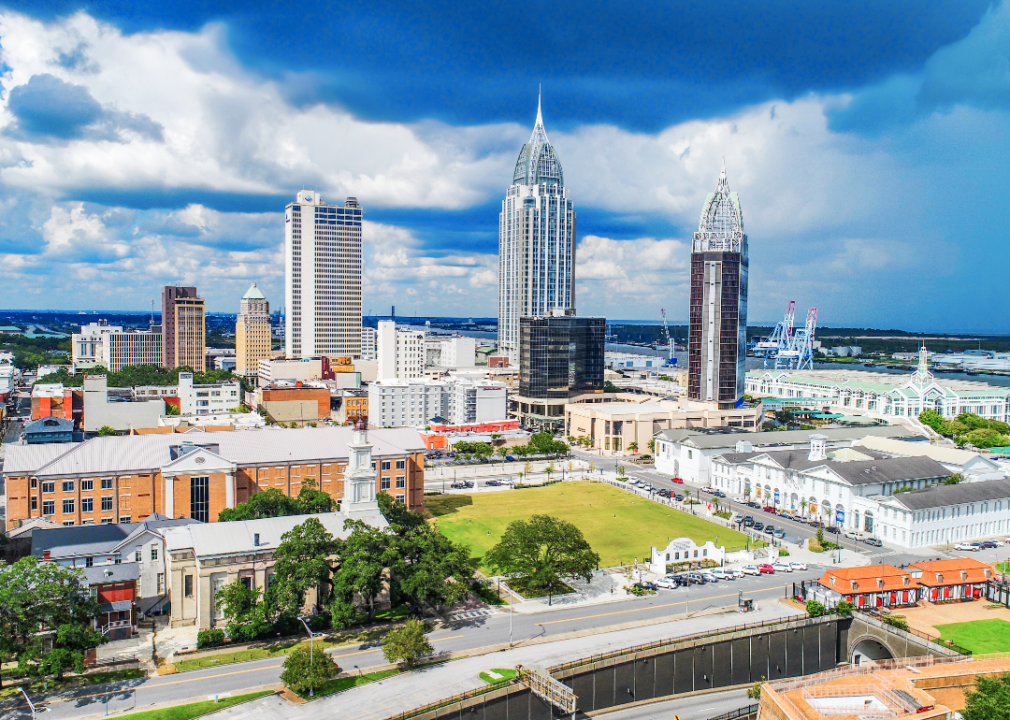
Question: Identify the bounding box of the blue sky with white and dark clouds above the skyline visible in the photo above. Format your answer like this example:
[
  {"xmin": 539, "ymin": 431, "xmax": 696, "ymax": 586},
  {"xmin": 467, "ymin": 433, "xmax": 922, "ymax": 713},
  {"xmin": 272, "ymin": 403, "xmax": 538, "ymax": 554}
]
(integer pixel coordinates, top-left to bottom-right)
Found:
[{"xmin": 0, "ymin": 0, "xmax": 1010, "ymax": 332}]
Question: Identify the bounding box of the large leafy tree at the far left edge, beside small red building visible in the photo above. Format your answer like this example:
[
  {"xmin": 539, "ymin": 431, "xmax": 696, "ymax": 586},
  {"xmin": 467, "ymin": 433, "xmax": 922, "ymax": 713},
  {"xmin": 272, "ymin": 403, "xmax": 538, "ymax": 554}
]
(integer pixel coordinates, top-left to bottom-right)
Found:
[{"xmin": 0, "ymin": 556, "xmax": 104, "ymax": 679}]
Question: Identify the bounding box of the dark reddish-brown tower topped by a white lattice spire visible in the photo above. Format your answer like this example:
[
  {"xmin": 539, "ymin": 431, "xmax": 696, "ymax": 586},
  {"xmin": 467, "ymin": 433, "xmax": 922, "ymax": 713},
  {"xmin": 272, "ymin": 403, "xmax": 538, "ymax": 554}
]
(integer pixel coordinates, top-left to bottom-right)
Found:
[{"xmin": 688, "ymin": 161, "xmax": 747, "ymax": 408}]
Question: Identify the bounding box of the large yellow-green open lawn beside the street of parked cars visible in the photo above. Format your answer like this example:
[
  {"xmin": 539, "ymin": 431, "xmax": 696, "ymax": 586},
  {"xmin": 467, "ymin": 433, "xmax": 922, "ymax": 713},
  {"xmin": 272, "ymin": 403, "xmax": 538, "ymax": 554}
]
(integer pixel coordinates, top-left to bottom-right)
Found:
[{"xmin": 424, "ymin": 481, "xmax": 746, "ymax": 567}]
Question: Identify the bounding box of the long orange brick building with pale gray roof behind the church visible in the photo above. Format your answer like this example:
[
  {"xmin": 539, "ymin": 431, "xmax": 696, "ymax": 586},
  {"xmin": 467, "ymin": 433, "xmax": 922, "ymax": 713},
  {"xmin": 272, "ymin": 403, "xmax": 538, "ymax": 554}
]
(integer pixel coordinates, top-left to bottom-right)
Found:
[{"xmin": 3, "ymin": 427, "xmax": 424, "ymax": 528}]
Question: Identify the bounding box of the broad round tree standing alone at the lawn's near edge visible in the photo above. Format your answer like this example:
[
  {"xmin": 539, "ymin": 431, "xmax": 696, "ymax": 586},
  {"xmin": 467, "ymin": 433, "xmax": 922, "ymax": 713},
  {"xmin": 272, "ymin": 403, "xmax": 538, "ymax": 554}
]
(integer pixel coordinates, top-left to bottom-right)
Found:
[{"xmin": 484, "ymin": 515, "xmax": 600, "ymax": 604}]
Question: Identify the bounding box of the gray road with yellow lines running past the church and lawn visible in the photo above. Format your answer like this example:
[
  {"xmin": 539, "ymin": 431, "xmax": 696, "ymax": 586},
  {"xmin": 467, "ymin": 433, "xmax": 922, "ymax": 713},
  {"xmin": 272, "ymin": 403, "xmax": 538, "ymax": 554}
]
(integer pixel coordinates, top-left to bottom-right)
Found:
[{"xmin": 0, "ymin": 567, "xmax": 822, "ymax": 720}]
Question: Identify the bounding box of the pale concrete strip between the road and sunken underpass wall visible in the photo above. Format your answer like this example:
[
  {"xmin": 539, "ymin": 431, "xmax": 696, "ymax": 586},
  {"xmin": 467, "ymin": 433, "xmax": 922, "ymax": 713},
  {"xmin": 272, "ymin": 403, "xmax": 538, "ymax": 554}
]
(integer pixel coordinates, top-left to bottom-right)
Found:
[{"xmin": 210, "ymin": 601, "xmax": 803, "ymax": 720}]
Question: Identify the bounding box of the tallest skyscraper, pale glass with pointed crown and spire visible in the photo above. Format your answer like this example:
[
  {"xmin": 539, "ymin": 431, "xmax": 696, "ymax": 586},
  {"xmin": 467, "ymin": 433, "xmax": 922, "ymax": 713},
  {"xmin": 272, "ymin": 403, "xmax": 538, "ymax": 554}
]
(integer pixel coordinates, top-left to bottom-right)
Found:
[{"xmin": 498, "ymin": 93, "xmax": 575, "ymax": 367}]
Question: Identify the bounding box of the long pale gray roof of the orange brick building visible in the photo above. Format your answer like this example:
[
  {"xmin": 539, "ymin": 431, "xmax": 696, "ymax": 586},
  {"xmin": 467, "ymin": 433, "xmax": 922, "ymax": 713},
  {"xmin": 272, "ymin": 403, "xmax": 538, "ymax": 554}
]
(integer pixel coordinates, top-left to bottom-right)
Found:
[{"xmin": 3, "ymin": 427, "xmax": 425, "ymax": 478}]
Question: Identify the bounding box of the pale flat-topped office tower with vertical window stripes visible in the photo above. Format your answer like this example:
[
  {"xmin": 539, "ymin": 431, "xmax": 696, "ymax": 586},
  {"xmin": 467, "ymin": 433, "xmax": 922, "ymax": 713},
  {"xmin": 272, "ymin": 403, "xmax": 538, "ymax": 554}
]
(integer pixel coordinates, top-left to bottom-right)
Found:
[{"xmin": 284, "ymin": 190, "xmax": 362, "ymax": 358}]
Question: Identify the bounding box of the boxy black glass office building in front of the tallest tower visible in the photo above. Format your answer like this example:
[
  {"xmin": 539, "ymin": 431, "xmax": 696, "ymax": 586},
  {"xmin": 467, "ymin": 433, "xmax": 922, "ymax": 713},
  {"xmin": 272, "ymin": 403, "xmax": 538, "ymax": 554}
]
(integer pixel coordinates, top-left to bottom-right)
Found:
[{"xmin": 519, "ymin": 315, "xmax": 607, "ymax": 400}]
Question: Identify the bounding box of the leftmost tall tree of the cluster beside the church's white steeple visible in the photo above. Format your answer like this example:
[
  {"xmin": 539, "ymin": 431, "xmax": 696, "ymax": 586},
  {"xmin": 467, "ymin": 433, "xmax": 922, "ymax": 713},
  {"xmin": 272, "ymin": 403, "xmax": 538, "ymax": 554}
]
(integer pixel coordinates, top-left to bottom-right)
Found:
[{"xmin": 267, "ymin": 517, "xmax": 336, "ymax": 618}]
